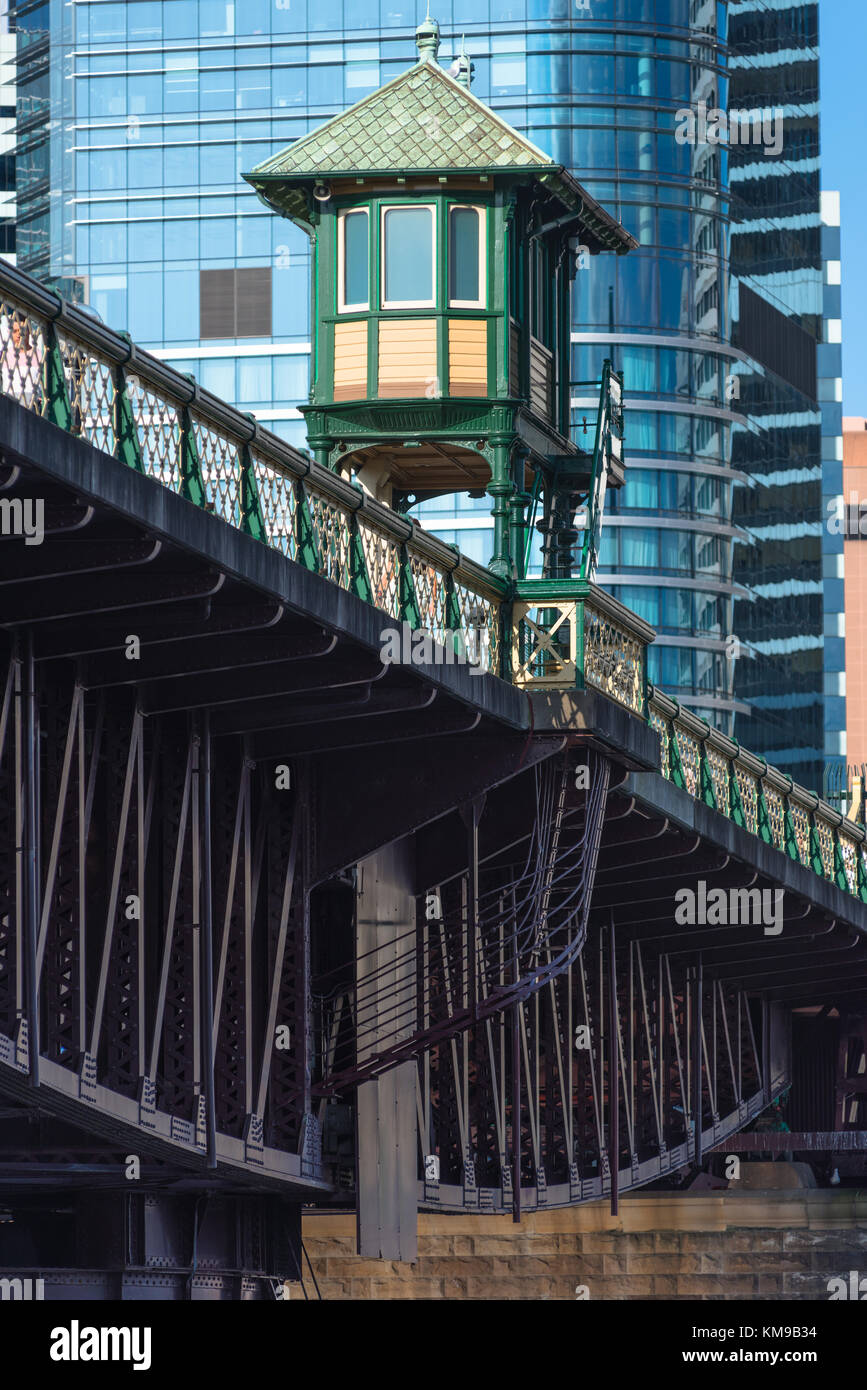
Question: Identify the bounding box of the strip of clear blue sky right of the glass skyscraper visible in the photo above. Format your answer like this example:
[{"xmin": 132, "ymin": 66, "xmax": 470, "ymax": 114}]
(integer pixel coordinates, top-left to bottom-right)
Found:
[{"xmin": 818, "ymin": 0, "xmax": 867, "ymax": 416}]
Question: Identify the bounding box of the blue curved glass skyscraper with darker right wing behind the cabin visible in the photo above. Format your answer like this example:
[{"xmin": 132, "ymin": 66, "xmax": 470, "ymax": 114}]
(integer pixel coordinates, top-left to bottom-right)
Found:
[{"xmin": 15, "ymin": 0, "xmax": 845, "ymax": 790}]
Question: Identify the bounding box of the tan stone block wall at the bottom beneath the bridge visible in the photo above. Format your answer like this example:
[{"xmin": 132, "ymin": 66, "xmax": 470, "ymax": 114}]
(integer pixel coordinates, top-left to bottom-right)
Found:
[{"xmin": 286, "ymin": 1188, "xmax": 867, "ymax": 1301}]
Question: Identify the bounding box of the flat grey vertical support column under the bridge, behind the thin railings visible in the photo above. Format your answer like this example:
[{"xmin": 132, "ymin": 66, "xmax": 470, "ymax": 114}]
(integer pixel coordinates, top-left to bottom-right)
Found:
[{"xmin": 356, "ymin": 838, "xmax": 418, "ymax": 1261}]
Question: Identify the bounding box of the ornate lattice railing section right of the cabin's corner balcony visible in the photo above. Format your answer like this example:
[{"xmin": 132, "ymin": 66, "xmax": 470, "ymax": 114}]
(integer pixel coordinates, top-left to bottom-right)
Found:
[{"xmin": 649, "ymin": 685, "xmax": 867, "ymax": 902}]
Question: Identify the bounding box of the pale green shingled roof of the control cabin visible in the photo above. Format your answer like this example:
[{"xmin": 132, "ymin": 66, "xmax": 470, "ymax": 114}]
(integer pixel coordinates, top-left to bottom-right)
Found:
[{"xmin": 247, "ymin": 61, "xmax": 557, "ymax": 185}]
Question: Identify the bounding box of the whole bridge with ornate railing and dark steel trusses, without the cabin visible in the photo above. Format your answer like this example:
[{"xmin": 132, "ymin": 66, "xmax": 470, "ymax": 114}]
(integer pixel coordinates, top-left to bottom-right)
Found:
[{"xmin": 0, "ymin": 252, "xmax": 867, "ymax": 1298}]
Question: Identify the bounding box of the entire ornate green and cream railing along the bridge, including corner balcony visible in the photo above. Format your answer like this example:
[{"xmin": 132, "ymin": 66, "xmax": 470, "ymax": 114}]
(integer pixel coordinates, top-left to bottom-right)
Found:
[{"xmin": 0, "ymin": 263, "xmax": 867, "ymax": 902}]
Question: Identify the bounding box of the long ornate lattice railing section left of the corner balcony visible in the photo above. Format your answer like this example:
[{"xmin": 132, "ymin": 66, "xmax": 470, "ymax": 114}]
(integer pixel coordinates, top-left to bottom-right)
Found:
[{"xmin": 0, "ymin": 263, "xmax": 509, "ymax": 671}]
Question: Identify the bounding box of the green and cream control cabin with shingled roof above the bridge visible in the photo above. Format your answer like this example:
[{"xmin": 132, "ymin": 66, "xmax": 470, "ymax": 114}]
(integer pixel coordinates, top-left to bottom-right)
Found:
[{"xmin": 245, "ymin": 18, "xmax": 635, "ymax": 578}]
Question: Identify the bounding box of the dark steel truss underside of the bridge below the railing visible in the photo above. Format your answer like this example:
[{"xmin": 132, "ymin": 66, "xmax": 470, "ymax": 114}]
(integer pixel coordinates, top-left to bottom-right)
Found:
[{"xmin": 0, "ymin": 399, "xmax": 867, "ymax": 1275}]
